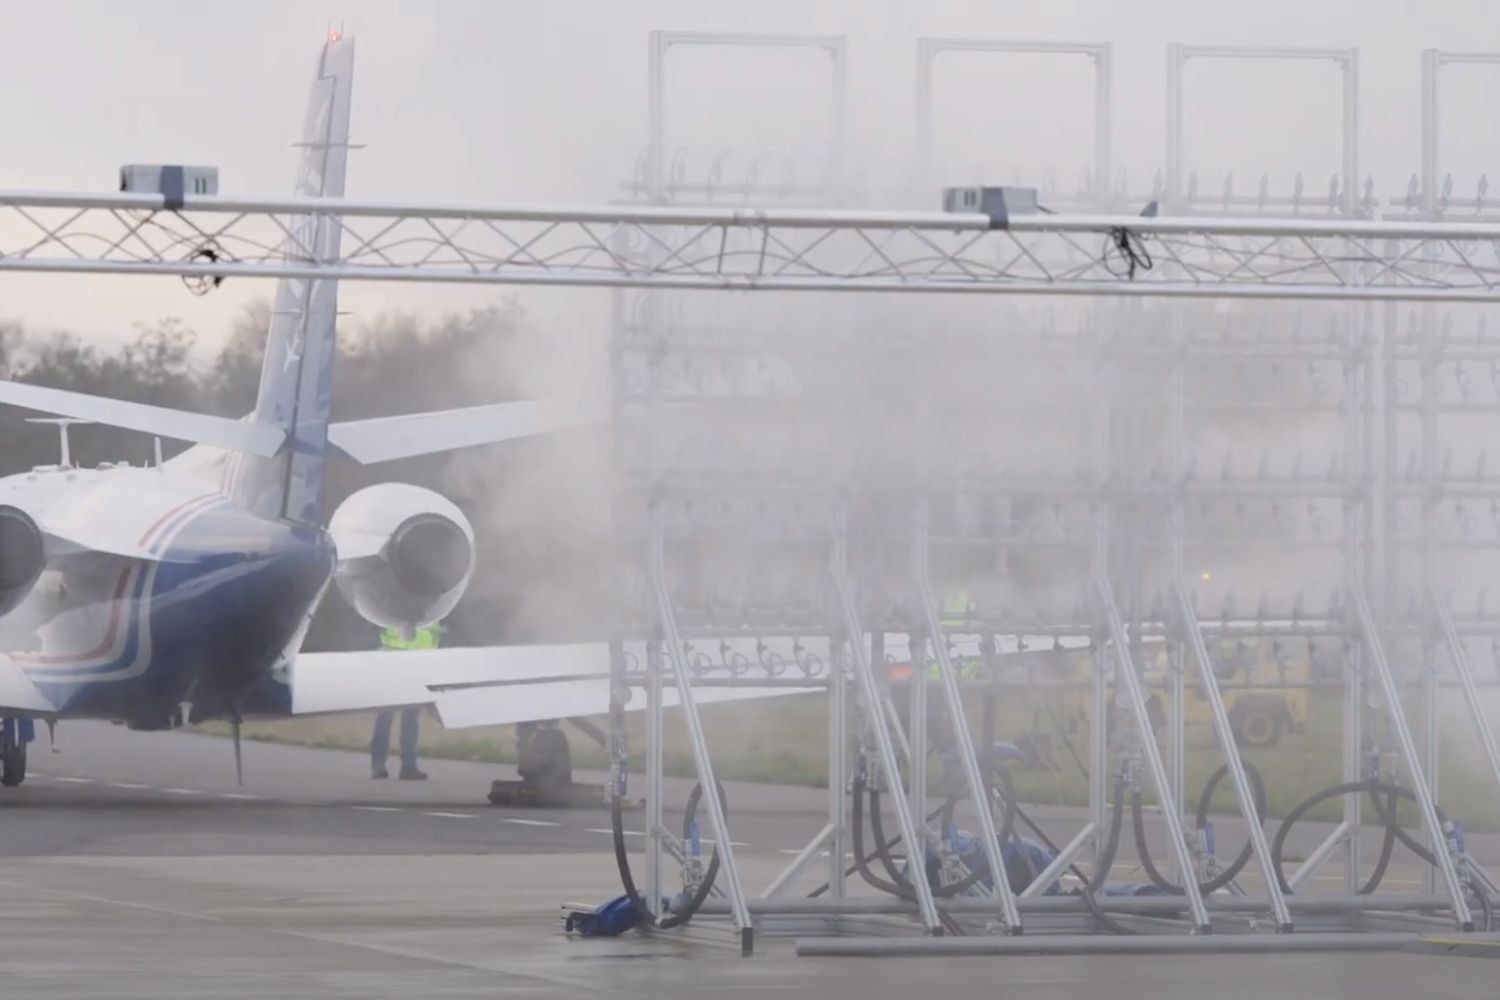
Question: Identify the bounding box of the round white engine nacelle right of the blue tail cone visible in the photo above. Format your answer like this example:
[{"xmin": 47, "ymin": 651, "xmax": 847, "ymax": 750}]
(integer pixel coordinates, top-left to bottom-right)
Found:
[{"xmin": 329, "ymin": 483, "xmax": 474, "ymax": 630}]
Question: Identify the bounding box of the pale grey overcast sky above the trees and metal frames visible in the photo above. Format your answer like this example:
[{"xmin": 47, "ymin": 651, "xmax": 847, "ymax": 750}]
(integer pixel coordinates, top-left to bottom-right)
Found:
[{"xmin": 0, "ymin": 0, "xmax": 1500, "ymax": 352}]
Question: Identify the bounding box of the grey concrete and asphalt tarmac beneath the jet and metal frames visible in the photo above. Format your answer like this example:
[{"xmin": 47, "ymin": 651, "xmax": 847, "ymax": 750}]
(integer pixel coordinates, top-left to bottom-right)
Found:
[{"xmin": 0, "ymin": 724, "xmax": 1500, "ymax": 1000}]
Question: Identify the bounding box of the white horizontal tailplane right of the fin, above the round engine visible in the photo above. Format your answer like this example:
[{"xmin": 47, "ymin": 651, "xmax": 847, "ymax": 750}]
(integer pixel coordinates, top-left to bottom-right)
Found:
[{"xmin": 329, "ymin": 399, "xmax": 609, "ymax": 465}]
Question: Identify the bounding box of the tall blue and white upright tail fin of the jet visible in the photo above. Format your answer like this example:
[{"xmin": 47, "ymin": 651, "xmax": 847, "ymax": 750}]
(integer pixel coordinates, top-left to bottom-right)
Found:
[{"xmin": 230, "ymin": 34, "xmax": 354, "ymax": 522}]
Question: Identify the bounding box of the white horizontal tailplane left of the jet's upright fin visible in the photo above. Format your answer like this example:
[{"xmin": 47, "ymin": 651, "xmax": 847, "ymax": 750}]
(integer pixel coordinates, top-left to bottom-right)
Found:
[{"xmin": 0, "ymin": 379, "xmax": 287, "ymax": 459}]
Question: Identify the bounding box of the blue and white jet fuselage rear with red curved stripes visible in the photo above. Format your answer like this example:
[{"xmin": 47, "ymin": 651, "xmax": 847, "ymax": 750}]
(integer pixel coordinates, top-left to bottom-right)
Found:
[{"xmin": 0, "ymin": 466, "xmax": 336, "ymax": 729}]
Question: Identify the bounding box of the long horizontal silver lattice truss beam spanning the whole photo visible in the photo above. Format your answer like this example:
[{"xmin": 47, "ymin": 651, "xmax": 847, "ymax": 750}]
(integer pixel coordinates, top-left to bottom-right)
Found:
[{"xmin": 0, "ymin": 192, "xmax": 1500, "ymax": 296}]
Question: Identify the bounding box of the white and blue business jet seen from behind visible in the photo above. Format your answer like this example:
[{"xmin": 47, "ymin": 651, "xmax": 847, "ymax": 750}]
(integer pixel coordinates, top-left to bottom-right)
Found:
[{"xmin": 0, "ymin": 36, "xmax": 785, "ymax": 786}]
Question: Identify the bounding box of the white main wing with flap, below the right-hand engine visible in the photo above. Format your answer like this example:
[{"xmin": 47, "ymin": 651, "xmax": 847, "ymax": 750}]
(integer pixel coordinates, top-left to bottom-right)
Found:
[{"xmin": 291, "ymin": 643, "xmax": 809, "ymax": 729}]
